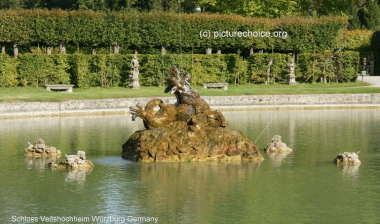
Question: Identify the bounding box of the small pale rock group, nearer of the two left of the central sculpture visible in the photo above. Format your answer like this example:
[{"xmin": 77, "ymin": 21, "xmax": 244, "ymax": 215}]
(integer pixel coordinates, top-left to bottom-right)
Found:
[{"xmin": 48, "ymin": 151, "xmax": 94, "ymax": 169}]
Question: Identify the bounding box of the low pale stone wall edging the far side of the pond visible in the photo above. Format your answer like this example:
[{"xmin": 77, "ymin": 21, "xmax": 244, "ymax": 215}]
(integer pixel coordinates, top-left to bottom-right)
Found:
[{"xmin": 0, "ymin": 94, "xmax": 380, "ymax": 117}]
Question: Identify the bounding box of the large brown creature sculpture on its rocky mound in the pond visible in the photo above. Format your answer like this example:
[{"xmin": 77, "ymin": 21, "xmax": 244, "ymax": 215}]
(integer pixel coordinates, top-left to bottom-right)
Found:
[{"xmin": 122, "ymin": 67, "xmax": 263, "ymax": 162}]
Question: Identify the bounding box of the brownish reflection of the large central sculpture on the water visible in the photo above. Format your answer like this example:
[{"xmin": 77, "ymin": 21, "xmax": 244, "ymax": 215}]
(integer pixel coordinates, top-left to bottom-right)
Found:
[{"xmin": 135, "ymin": 162, "xmax": 261, "ymax": 222}]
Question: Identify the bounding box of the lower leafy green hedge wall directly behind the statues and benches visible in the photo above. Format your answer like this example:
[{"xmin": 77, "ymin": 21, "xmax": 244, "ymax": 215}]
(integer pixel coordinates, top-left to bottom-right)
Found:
[{"xmin": 0, "ymin": 51, "xmax": 359, "ymax": 88}]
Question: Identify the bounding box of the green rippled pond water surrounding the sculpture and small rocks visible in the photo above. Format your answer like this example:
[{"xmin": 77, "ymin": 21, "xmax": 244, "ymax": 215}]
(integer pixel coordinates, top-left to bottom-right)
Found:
[{"xmin": 0, "ymin": 109, "xmax": 380, "ymax": 223}]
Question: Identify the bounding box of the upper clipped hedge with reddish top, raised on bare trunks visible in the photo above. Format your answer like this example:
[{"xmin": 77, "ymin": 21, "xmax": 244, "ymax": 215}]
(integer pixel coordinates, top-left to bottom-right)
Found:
[{"xmin": 0, "ymin": 9, "xmax": 347, "ymax": 51}]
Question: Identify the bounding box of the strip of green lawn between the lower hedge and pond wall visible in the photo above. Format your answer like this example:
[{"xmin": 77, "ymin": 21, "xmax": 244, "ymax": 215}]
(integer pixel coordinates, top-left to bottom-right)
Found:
[{"xmin": 0, "ymin": 82, "xmax": 380, "ymax": 102}]
